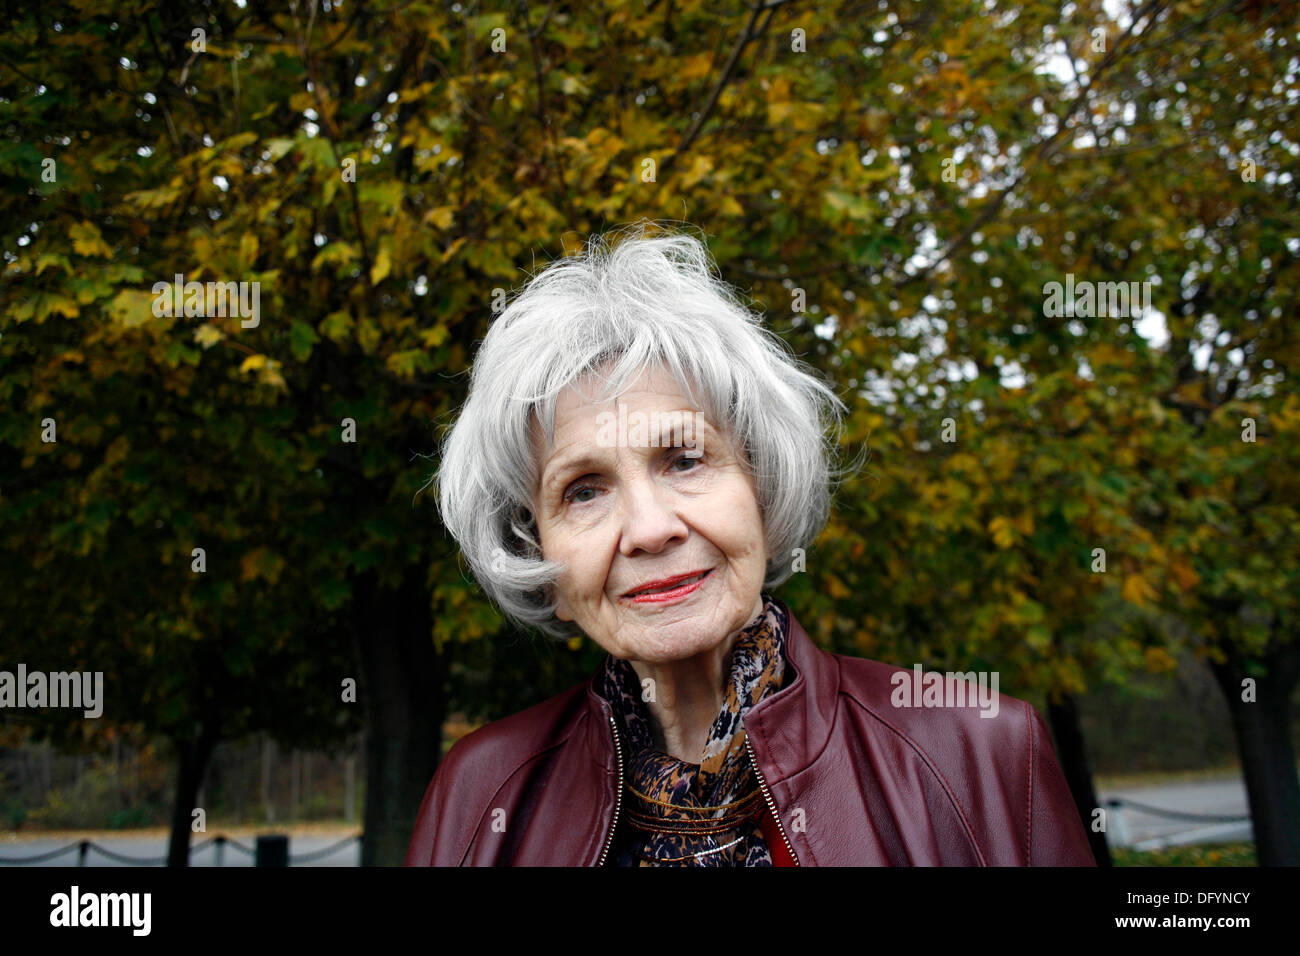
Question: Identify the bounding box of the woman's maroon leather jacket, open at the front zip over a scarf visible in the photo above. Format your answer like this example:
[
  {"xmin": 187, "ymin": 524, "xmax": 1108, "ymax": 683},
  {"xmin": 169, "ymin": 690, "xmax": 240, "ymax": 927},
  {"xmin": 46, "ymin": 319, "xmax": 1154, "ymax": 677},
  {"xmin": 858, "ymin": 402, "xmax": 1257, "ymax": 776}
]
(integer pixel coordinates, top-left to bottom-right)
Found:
[{"xmin": 406, "ymin": 605, "xmax": 1095, "ymax": 866}]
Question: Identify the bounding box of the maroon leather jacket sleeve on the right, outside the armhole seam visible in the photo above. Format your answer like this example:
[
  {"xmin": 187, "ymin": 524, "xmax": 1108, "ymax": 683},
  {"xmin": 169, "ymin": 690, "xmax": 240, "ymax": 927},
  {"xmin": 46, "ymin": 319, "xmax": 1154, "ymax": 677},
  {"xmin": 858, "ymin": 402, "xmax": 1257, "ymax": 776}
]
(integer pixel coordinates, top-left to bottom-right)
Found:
[{"xmin": 1026, "ymin": 704, "xmax": 1097, "ymax": 866}]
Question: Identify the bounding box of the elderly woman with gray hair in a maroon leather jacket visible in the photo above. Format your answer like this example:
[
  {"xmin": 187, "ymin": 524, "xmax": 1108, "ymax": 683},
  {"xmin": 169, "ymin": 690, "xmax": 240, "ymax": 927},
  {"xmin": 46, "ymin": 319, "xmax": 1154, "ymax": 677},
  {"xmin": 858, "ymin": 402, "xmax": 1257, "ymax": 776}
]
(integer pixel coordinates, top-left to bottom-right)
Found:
[{"xmin": 407, "ymin": 223, "xmax": 1092, "ymax": 866}]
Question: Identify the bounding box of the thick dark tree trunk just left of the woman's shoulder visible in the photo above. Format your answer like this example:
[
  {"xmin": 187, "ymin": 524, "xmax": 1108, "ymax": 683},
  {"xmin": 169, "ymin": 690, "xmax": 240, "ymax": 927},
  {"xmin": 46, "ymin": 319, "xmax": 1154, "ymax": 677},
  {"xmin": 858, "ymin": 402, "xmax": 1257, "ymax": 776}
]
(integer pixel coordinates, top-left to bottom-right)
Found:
[{"xmin": 354, "ymin": 570, "xmax": 446, "ymax": 866}]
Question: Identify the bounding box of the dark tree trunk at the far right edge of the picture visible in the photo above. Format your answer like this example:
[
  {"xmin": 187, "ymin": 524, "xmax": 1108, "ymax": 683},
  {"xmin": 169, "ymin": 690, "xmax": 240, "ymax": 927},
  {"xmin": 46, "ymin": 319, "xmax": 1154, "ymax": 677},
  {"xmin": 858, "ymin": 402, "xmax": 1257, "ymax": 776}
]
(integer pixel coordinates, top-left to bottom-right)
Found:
[{"xmin": 1210, "ymin": 634, "xmax": 1300, "ymax": 866}]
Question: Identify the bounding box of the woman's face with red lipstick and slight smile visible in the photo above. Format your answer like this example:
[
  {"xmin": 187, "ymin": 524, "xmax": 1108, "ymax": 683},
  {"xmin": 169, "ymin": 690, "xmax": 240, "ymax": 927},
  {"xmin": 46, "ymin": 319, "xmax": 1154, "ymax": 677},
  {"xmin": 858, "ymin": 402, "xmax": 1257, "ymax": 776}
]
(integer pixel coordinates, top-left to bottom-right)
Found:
[{"xmin": 533, "ymin": 368, "xmax": 767, "ymax": 663}]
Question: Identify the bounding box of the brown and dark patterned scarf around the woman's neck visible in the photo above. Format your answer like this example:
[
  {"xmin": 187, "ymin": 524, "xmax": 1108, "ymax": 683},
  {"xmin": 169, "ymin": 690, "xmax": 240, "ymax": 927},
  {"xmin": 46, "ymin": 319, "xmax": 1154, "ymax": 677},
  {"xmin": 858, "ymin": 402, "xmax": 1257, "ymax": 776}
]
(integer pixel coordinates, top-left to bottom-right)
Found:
[{"xmin": 602, "ymin": 594, "xmax": 785, "ymax": 866}]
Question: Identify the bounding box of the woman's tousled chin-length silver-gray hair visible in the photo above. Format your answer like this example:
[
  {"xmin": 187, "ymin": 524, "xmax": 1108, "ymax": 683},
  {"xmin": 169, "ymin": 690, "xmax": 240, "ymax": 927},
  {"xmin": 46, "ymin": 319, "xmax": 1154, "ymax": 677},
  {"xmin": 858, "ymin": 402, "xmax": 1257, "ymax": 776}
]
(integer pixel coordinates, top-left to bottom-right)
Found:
[{"xmin": 437, "ymin": 220, "xmax": 844, "ymax": 637}]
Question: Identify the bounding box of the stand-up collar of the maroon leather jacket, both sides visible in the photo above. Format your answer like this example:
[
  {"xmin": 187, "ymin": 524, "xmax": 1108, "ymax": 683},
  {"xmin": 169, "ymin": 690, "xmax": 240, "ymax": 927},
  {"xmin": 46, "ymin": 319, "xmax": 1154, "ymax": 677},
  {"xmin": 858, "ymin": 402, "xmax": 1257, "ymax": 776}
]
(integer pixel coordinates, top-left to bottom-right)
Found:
[{"xmin": 585, "ymin": 598, "xmax": 840, "ymax": 786}]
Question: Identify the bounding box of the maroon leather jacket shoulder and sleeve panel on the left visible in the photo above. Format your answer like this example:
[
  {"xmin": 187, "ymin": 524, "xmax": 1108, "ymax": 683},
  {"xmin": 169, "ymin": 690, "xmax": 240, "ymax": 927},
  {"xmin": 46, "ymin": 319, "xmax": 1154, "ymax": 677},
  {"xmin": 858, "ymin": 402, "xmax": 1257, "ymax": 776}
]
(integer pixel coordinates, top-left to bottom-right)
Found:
[{"xmin": 406, "ymin": 683, "xmax": 586, "ymax": 866}]
